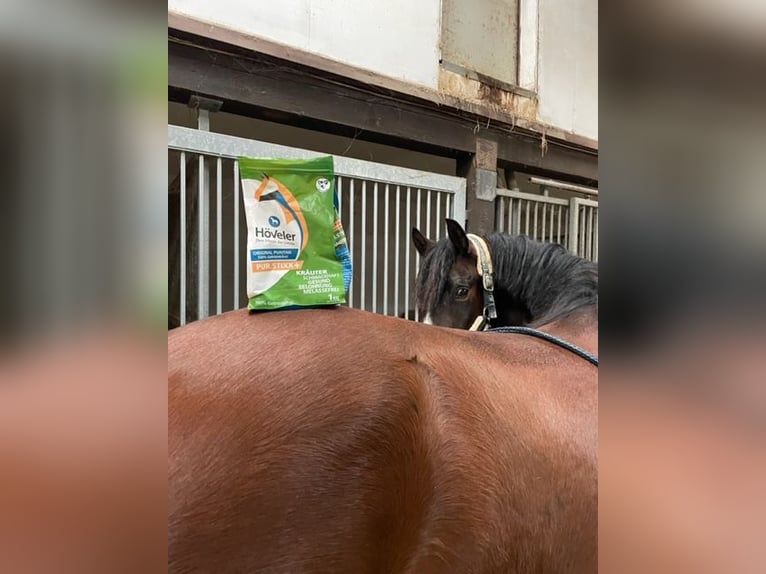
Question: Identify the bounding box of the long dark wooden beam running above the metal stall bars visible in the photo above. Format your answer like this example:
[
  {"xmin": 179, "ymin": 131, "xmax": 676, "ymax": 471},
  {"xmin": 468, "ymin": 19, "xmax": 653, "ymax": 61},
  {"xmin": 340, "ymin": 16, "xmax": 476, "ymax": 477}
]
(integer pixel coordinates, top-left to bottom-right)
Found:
[{"xmin": 168, "ymin": 30, "xmax": 598, "ymax": 185}]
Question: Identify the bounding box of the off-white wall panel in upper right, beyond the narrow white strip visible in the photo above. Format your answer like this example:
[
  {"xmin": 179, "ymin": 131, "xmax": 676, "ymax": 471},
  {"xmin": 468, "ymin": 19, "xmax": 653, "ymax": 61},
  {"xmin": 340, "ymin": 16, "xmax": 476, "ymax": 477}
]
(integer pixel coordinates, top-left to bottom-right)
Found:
[{"xmin": 537, "ymin": 0, "xmax": 598, "ymax": 140}]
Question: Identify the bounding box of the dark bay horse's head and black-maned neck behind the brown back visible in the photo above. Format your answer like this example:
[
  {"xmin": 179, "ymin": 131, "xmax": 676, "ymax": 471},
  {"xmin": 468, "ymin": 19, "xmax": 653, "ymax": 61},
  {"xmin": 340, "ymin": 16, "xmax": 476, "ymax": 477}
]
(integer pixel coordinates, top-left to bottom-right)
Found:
[{"xmin": 412, "ymin": 219, "xmax": 598, "ymax": 329}]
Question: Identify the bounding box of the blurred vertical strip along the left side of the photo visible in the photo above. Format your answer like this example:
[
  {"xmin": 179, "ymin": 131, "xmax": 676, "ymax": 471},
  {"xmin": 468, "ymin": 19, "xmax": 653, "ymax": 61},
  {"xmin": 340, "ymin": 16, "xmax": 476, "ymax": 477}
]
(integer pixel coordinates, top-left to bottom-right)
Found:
[{"xmin": 0, "ymin": 0, "xmax": 167, "ymax": 574}]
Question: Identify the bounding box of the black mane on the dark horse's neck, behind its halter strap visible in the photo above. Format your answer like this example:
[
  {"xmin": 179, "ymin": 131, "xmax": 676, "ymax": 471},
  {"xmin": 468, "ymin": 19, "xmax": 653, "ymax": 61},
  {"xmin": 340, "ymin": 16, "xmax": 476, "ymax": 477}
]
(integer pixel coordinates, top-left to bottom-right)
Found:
[{"xmin": 486, "ymin": 233, "xmax": 598, "ymax": 326}]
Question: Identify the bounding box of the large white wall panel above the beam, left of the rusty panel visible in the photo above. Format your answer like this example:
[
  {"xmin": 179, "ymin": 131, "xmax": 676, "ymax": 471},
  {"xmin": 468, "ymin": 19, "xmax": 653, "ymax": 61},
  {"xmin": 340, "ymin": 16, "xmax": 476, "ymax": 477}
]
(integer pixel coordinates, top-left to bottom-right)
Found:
[{"xmin": 168, "ymin": 0, "xmax": 440, "ymax": 89}]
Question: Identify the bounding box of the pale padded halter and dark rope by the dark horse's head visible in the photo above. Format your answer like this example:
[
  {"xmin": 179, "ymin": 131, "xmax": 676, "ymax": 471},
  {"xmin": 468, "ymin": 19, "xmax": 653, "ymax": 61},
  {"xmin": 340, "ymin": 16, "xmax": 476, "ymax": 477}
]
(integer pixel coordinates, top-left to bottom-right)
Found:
[{"xmin": 468, "ymin": 233, "xmax": 598, "ymax": 367}]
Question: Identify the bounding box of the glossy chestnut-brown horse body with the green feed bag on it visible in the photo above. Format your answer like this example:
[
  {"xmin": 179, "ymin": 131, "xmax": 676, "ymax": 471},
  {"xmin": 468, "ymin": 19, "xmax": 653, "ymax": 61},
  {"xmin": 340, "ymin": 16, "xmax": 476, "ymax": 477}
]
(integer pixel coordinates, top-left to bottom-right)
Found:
[{"xmin": 168, "ymin": 308, "xmax": 598, "ymax": 574}]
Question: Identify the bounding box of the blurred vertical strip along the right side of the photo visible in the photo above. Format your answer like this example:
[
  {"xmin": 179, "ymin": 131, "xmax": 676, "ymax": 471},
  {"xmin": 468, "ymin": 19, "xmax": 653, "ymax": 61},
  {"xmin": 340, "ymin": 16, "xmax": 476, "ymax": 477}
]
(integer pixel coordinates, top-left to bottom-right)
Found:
[{"xmin": 599, "ymin": 0, "xmax": 766, "ymax": 574}]
